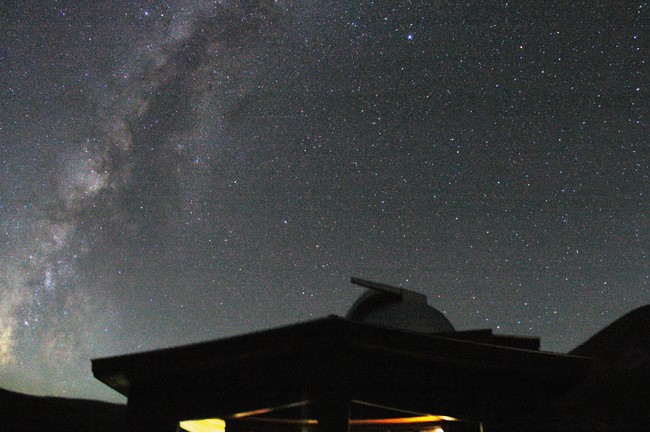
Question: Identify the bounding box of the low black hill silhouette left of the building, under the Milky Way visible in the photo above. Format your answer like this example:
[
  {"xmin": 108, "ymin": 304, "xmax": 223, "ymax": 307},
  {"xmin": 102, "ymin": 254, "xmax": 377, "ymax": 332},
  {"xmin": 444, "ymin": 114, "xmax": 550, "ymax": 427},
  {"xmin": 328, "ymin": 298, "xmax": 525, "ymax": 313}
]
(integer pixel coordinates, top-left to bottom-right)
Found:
[{"xmin": 0, "ymin": 389, "xmax": 126, "ymax": 431}]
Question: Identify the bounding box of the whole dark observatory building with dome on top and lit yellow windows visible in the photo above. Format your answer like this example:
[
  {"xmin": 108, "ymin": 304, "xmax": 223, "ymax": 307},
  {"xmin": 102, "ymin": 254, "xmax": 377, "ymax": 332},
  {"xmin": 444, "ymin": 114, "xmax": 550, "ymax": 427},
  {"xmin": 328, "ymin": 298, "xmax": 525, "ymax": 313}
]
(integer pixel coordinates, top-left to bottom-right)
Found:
[{"xmin": 92, "ymin": 278, "xmax": 591, "ymax": 431}]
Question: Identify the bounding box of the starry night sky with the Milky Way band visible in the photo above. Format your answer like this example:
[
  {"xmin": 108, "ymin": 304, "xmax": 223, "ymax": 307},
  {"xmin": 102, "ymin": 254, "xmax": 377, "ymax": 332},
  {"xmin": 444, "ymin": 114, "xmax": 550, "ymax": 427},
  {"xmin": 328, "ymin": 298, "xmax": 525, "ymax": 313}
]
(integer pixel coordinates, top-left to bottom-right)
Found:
[{"xmin": 0, "ymin": 0, "xmax": 650, "ymax": 401}]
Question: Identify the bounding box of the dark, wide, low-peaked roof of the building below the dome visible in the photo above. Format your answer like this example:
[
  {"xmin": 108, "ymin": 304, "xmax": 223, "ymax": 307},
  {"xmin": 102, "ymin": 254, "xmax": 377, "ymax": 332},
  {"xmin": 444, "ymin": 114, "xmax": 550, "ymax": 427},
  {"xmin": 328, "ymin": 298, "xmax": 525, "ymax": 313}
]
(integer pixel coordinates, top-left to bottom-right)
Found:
[{"xmin": 92, "ymin": 316, "xmax": 590, "ymax": 402}]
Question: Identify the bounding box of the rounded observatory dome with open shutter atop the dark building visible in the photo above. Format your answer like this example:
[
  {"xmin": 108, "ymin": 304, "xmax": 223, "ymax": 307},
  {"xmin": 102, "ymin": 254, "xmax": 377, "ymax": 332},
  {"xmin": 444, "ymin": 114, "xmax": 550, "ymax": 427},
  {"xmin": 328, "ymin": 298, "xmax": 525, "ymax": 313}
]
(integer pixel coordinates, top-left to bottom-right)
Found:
[{"xmin": 346, "ymin": 278, "xmax": 454, "ymax": 333}]
